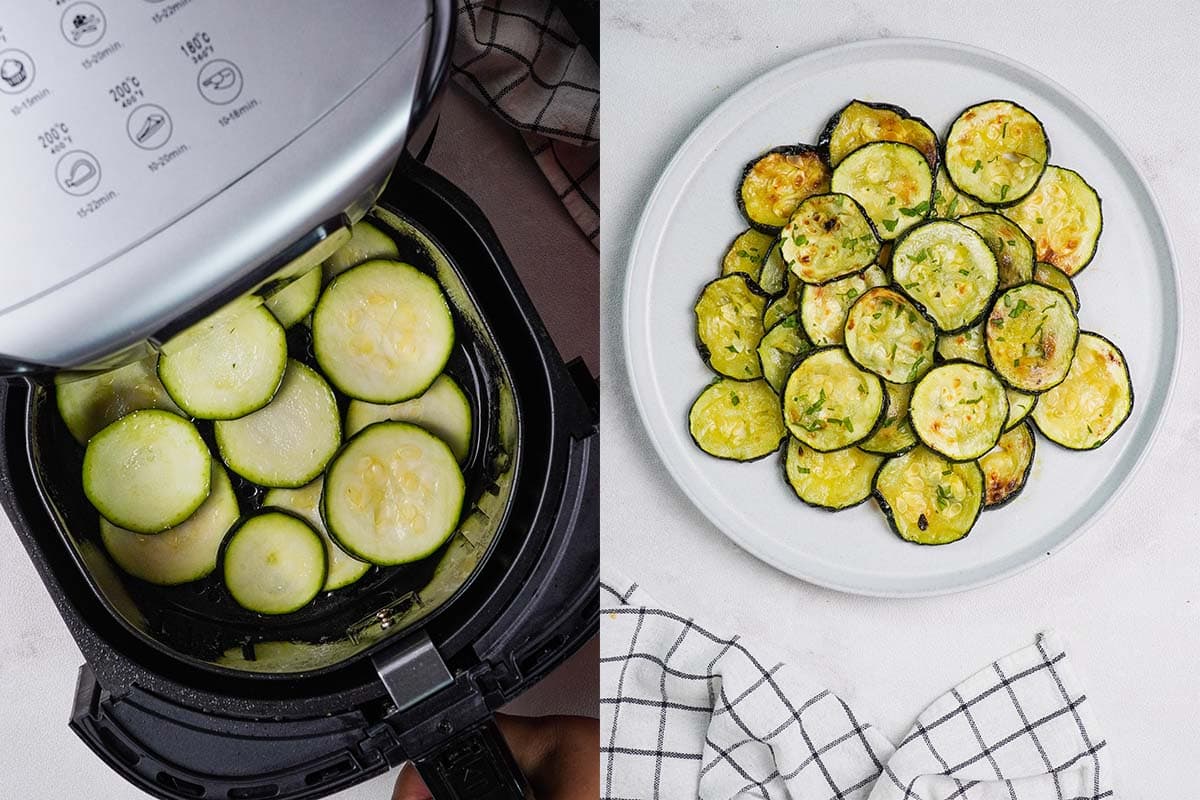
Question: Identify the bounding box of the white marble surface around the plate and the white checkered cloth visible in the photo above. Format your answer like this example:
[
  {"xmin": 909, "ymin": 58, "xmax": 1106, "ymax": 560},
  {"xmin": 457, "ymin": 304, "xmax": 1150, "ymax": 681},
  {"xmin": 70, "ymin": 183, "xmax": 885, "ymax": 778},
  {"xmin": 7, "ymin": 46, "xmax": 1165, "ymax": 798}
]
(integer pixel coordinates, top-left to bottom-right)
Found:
[{"xmin": 601, "ymin": 0, "xmax": 1200, "ymax": 796}]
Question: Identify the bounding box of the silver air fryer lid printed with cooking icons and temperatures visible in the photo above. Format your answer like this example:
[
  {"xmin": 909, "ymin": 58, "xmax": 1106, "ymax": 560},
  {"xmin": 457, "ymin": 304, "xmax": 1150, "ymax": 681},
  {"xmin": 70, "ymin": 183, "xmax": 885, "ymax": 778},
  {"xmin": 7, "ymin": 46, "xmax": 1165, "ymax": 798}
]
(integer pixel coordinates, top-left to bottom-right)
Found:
[{"xmin": 0, "ymin": 0, "xmax": 450, "ymax": 373}]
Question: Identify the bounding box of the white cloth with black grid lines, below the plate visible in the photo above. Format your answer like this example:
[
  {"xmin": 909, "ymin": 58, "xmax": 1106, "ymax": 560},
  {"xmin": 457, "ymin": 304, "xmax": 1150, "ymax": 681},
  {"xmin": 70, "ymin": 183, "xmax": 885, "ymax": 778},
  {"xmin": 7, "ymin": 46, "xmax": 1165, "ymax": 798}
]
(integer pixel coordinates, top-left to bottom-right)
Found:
[{"xmin": 600, "ymin": 575, "xmax": 1114, "ymax": 800}]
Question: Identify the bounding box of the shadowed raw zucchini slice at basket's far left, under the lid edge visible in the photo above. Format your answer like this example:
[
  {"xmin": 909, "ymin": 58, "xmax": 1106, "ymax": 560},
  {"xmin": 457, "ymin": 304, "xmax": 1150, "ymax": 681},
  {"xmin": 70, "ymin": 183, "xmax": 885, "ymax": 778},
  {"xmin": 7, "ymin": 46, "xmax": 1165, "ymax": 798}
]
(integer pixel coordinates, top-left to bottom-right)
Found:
[{"xmin": 54, "ymin": 357, "xmax": 182, "ymax": 444}]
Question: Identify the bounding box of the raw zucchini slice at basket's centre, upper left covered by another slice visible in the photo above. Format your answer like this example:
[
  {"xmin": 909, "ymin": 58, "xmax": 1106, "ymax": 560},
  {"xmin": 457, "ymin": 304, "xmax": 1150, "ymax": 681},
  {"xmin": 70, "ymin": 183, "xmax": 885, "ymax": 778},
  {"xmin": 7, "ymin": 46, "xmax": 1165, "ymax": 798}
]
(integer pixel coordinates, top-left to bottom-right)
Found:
[{"xmin": 212, "ymin": 360, "xmax": 342, "ymax": 487}]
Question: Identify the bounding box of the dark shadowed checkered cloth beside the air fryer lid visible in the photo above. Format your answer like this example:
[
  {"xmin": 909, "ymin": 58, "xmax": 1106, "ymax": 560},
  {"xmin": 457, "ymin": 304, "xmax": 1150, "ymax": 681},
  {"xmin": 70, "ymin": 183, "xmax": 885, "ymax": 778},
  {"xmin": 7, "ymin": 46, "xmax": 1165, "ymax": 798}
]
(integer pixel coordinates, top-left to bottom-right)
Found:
[{"xmin": 451, "ymin": 0, "xmax": 600, "ymax": 247}]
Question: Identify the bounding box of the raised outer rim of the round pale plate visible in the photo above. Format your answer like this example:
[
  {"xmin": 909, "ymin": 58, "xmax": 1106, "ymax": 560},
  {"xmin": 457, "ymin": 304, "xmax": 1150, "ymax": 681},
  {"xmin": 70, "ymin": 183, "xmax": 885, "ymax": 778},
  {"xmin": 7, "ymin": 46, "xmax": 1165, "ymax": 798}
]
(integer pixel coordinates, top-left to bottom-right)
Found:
[{"xmin": 620, "ymin": 36, "xmax": 1183, "ymax": 599}]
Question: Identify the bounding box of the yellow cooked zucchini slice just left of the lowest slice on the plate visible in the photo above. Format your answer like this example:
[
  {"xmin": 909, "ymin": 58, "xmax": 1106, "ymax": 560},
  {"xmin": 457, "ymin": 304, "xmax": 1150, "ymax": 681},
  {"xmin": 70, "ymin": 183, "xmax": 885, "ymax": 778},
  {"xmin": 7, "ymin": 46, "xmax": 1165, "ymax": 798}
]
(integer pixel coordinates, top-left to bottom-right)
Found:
[{"xmin": 784, "ymin": 439, "xmax": 883, "ymax": 511}]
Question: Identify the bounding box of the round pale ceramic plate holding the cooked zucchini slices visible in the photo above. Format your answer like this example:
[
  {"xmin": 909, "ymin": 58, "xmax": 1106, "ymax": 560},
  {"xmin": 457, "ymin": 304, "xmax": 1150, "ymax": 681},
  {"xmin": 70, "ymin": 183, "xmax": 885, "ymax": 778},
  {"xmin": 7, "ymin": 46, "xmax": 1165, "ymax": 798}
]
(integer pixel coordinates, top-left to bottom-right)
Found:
[{"xmin": 624, "ymin": 40, "xmax": 1180, "ymax": 596}]
